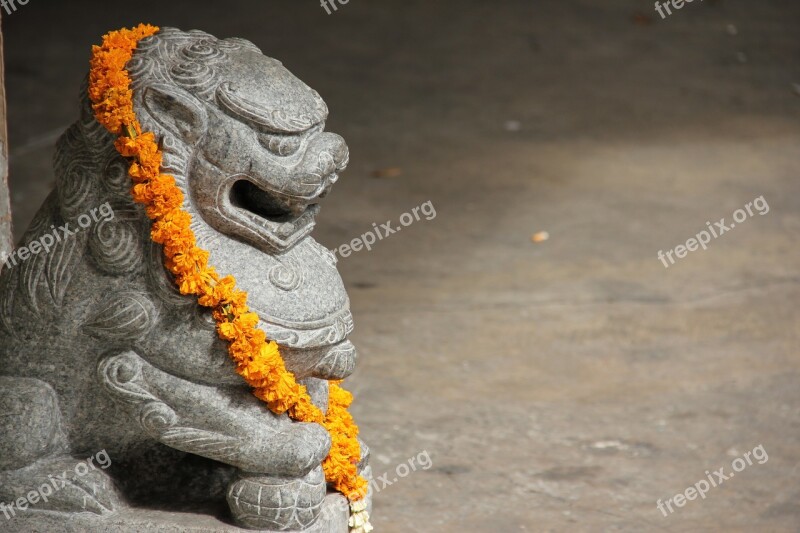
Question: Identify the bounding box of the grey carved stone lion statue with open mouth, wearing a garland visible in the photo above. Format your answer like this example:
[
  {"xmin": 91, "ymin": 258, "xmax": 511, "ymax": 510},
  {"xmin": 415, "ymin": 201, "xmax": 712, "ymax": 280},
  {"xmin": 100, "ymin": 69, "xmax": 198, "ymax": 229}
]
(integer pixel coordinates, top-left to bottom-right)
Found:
[{"xmin": 0, "ymin": 28, "xmax": 369, "ymax": 531}]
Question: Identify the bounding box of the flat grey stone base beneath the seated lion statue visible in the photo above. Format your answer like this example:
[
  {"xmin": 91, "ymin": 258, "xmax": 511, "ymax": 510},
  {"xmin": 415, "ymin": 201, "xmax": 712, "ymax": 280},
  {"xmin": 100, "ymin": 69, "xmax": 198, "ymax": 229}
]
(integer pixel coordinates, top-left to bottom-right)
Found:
[{"xmin": 0, "ymin": 493, "xmax": 349, "ymax": 533}]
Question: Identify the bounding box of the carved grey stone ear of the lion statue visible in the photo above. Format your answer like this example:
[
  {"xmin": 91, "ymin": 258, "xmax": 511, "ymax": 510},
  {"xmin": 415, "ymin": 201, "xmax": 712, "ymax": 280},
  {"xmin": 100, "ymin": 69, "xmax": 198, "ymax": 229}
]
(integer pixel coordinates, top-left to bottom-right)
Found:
[{"xmin": 144, "ymin": 85, "xmax": 208, "ymax": 146}]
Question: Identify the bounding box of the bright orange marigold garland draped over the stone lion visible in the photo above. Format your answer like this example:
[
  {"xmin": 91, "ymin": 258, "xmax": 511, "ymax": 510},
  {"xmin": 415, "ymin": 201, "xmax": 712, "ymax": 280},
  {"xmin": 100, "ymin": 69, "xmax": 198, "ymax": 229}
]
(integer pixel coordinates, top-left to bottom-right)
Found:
[{"xmin": 89, "ymin": 24, "xmax": 372, "ymax": 532}]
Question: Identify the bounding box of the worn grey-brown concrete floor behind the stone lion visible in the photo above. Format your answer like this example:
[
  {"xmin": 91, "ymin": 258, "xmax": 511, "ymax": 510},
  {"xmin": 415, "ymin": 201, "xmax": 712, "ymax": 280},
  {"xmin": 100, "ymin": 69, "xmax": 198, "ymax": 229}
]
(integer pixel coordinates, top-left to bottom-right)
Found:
[{"xmin": 4, "ymin": 0, "xmax": 800, "ymax": 533}]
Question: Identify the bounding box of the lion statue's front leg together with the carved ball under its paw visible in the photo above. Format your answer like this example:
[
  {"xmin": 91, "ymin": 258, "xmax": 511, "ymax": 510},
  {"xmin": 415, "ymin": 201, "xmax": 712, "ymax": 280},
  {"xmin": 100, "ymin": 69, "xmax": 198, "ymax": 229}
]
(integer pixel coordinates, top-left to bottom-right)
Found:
[{"xmin": 98, "ymin": 351, "xmax": 331, "ymax": 531}]
